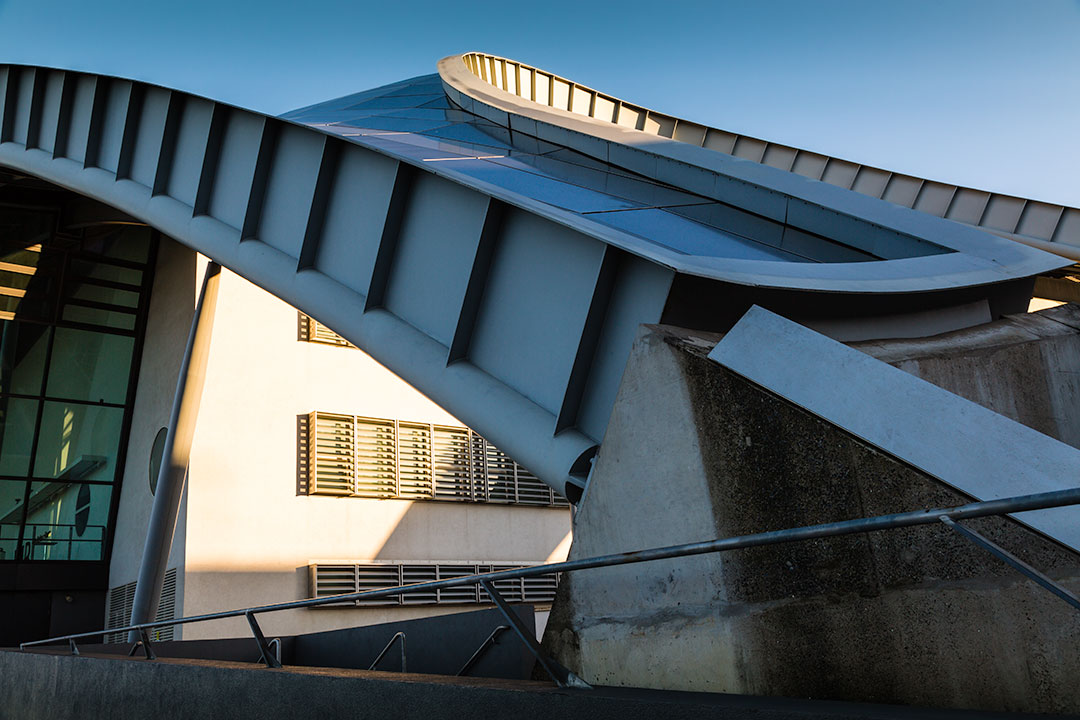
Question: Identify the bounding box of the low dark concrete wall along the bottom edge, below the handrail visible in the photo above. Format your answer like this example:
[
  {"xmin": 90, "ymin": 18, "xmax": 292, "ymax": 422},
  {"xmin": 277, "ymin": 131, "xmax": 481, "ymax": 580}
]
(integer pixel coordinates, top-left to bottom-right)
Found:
[{"xmin": 0, "ymin": 651, "xmax": 1049, "ymax": 720}]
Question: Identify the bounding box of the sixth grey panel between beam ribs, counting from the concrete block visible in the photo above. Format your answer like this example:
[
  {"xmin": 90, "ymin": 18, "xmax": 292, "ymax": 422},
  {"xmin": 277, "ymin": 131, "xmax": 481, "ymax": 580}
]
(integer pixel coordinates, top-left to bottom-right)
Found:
[{"xmin": 207, "ymin": 110, "xmax": 262, "ymax": 230}]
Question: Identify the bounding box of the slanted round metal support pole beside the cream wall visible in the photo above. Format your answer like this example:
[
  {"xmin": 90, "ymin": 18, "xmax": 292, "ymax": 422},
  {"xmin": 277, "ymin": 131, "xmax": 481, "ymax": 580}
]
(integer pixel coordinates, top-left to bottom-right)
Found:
[{"xmin": 127, "ymin": 261, "xmax": 221, "ymax": 642}]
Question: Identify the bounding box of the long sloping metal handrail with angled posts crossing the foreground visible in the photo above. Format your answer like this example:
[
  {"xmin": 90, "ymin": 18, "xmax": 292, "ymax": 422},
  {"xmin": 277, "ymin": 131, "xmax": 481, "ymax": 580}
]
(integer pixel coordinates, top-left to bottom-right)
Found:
[{"xmin": 19, "ymin": 487, "xmax": 1080, "ymax": 685}]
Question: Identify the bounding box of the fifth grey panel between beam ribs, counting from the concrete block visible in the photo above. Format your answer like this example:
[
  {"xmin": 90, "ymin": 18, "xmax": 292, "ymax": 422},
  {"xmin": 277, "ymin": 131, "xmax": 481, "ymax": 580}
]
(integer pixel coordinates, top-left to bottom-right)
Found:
[{"xmin": 258, "ymin": 125, "xmax": 324, "ymax": 258}]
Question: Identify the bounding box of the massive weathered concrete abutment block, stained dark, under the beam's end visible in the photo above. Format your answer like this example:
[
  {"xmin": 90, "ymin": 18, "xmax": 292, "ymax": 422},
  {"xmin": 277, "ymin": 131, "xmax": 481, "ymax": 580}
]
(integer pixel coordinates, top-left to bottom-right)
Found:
[{"xmin": 544, "ymin": 310, "xmax": 1080, "ymax": 712}]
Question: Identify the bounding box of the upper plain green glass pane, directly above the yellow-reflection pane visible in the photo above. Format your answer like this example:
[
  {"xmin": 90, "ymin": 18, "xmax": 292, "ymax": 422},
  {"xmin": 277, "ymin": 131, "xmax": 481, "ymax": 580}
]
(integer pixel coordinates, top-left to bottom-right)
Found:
[{"xmin": 45, "ymin": 327, "xmax": 135, "ymax": 403}]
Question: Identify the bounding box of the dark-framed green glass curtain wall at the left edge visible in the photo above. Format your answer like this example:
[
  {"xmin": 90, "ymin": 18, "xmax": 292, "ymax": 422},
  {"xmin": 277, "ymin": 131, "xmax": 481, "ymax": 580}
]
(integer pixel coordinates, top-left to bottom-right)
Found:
[{"xmin": 0, "ymin": 204, "xmax": 156, "ymax": 562}]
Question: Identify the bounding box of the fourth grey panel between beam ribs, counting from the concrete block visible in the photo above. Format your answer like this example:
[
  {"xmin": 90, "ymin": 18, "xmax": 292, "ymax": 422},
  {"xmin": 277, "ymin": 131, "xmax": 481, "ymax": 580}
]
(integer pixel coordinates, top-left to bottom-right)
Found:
[{"xmin": 314, "ymin": 147, "xmax": 397, "ymax": 288}]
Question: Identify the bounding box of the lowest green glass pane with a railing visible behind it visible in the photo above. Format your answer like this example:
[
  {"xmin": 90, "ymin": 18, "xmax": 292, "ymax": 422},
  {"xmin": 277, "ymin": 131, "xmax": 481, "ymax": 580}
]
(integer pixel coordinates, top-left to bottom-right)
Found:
[{"xmin": 23, "ymin": 483, "xmax": 112, "ymax": 560}]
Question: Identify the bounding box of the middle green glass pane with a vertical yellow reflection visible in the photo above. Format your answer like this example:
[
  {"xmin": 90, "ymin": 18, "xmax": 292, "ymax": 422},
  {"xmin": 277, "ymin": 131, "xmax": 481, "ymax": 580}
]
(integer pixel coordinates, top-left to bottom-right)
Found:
[{"xmin": 33, "ymin": 403, "xmax": 124, "ymax": 483}]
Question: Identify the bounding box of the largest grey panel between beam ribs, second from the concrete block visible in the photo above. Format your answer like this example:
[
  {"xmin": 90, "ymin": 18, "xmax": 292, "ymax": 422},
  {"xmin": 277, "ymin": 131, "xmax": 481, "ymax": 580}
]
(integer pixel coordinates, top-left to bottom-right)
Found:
[{"xmin": 469, "ymin": 209, "xmax": 604, "ymax": 415}]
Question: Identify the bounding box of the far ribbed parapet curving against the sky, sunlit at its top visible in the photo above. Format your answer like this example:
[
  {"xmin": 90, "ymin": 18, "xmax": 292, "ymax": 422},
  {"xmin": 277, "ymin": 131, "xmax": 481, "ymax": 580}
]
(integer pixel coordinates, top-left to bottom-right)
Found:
[{"xmin": 441, "ymin": 52, "xmax": 1080, "ymax": 260}]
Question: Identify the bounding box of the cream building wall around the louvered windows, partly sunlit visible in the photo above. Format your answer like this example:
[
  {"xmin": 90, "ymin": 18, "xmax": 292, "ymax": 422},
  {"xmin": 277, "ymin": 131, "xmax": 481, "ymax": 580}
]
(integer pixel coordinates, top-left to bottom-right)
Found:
[{"xmin": 110, "ymin": 252, "xmax": 570, "ymax": 639}]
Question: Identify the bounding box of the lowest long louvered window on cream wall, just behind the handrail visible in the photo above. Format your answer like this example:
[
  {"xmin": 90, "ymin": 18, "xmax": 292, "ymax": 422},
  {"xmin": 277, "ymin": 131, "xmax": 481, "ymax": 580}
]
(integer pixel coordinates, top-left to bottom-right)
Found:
[{"xmin": 309, "ymin": 562, "xmax": 558, "ymax": 608}]
